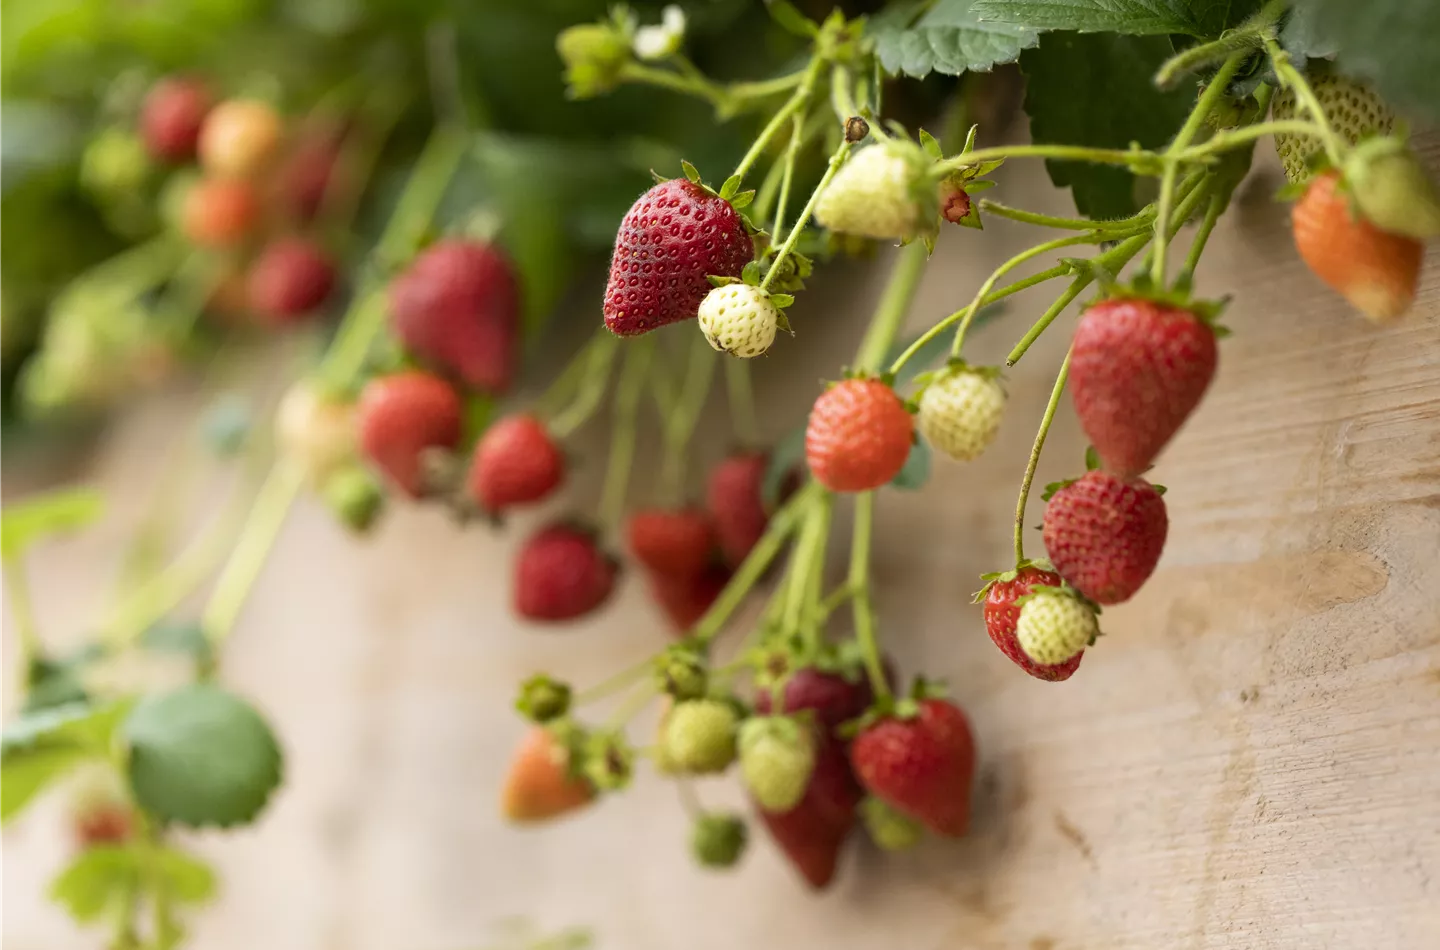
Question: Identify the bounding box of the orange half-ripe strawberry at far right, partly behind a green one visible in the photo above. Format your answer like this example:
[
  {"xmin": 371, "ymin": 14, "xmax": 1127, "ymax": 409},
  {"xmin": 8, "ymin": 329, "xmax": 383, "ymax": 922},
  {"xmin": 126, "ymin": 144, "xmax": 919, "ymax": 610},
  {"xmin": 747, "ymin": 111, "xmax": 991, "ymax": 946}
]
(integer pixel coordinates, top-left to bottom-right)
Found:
[{"xmin": 1290, "ymin": 170, "xmax": 1424, "ymax": 322}]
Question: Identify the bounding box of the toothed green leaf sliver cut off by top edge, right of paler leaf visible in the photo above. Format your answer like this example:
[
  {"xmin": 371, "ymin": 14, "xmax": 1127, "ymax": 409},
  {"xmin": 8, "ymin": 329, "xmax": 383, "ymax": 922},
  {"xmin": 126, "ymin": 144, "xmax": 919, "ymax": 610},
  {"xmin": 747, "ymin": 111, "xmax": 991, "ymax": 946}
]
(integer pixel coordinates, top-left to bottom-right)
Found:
[{"xmin": 973, "ymin": 0, "xmax": 1230, "ymax": 36}]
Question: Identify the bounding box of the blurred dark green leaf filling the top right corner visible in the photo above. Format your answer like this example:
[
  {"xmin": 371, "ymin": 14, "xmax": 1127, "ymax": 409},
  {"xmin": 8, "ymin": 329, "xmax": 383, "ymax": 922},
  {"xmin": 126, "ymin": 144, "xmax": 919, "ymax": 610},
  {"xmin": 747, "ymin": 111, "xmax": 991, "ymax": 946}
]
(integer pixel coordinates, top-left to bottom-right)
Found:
[{"xmin": 1295, "ymin": 0, "xmax": 1440, "ymax": 119}]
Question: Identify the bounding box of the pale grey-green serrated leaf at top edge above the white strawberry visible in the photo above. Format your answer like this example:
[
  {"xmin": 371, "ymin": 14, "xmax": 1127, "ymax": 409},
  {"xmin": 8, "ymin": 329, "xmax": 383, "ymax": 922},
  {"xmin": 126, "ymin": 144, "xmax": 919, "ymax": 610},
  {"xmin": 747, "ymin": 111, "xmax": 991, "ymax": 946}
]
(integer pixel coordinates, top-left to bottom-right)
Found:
[{"xmin": 876, "ymin": 0, "xmax": 1040, "ymax": 78}]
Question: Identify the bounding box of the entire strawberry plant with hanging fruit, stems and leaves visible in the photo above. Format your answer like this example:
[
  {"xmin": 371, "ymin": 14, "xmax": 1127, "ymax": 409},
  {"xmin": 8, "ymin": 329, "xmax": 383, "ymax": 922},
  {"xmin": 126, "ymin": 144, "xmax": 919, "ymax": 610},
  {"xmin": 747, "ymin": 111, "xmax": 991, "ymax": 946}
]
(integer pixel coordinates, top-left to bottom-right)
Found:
[{"xmin": 0, "ymin": 0, "xmax": 1440, "ymax": 949}]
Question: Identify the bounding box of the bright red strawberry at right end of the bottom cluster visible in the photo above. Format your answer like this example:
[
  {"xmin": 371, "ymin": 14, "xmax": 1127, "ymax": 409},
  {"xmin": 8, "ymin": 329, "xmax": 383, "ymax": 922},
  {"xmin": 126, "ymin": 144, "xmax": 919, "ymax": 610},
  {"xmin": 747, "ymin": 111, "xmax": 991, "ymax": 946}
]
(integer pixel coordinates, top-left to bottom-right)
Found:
[{"xmin": 850, "ymin": 700, "xmax": 975, "ymax": 838}]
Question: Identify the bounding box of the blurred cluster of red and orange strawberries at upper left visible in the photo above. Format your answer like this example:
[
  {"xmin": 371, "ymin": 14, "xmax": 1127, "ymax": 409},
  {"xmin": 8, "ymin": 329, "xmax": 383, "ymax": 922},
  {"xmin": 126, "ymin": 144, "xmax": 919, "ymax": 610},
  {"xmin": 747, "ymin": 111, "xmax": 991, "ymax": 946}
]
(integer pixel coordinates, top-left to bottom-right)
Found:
[{"xmin": 138, "ymin": 76, "xmax": 346, "ymax": 324}]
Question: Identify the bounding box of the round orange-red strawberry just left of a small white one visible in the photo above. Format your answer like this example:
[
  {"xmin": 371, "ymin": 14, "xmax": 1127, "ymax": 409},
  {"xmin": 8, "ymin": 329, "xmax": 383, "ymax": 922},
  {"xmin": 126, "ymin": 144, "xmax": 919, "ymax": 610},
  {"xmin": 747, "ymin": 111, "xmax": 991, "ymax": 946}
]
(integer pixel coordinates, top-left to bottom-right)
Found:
[{"xmin": 805, "ymin": 379, "xmax": 914, "ymax": 491}]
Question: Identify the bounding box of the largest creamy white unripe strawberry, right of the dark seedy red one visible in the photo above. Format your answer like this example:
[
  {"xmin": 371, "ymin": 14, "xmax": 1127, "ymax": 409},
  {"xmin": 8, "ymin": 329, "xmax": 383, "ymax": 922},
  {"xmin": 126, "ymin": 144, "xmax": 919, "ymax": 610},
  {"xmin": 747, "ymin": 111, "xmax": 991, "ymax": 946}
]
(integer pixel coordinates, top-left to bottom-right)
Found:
[{"xmin": 815, "ymin": 140, "xmax": 939, "ymax": 240}]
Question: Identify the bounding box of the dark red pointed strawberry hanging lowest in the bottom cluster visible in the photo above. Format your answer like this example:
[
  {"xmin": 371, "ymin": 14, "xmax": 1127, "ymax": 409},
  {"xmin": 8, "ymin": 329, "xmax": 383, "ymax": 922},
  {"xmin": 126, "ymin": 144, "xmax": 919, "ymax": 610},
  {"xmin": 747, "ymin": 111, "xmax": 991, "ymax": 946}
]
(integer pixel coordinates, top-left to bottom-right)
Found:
[{"xmin": 757, "ymin": 738, "xmax": 863, "ymax": 890}]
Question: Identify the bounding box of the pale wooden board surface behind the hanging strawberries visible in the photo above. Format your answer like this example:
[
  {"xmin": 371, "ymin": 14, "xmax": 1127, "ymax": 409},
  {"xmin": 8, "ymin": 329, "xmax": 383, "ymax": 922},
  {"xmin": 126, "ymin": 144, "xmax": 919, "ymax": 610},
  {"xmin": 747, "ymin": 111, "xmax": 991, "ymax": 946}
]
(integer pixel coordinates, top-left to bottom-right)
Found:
[{"xmin": 3, "ymin": 143, "xmax": 1440, "ymax": 950}]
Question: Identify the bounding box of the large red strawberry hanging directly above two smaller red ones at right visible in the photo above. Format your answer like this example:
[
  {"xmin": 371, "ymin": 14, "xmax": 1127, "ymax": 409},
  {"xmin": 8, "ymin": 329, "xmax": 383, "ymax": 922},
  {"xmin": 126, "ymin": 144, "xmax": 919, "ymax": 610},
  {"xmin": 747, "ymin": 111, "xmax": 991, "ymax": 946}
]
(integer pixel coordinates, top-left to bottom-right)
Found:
[{"xmin": 1070, "ymin": 298, "xmax": 1217, "ymax": 476}]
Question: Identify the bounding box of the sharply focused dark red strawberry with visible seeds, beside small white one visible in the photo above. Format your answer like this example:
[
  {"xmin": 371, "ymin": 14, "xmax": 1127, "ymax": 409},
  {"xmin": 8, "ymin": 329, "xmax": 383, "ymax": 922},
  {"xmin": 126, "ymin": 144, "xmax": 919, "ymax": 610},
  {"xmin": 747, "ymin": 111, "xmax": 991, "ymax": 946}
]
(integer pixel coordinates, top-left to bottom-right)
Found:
[{"xmin": 605, "ymin": 178, "xmax": 755, "ymax": 337}]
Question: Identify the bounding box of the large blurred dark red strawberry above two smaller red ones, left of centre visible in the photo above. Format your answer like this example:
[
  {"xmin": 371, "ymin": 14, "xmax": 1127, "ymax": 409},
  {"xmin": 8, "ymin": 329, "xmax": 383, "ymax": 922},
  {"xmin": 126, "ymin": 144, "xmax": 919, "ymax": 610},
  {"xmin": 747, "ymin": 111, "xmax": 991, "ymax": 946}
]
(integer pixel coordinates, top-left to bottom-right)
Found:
[{"xmin": 390, "ymin": 240, "xmax": 520, "ymax": 393}]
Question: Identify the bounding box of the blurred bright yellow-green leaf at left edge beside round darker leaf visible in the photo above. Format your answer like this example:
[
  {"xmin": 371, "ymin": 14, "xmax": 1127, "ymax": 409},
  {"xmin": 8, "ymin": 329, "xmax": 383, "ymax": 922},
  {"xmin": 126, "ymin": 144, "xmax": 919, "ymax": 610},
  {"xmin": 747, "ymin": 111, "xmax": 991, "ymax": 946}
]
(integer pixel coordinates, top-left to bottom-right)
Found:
[{"xmin": 0, "ymin": 702, "xmax": 130, "ymax": 822}]
